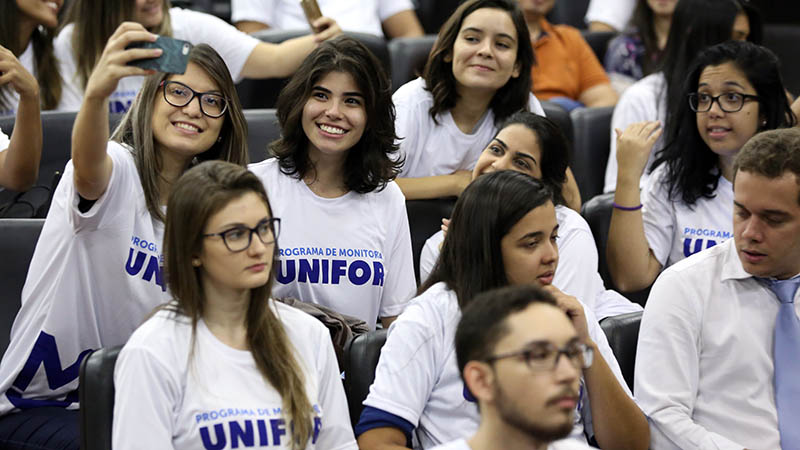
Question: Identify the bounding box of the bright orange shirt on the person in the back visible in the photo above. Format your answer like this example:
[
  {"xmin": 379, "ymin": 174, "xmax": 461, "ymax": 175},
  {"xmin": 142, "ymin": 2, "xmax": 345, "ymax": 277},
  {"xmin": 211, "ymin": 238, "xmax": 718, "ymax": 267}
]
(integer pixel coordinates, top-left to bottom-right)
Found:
[{"xmin": 531, "ymin": 19, "xmax": 609, "ymax": 100}]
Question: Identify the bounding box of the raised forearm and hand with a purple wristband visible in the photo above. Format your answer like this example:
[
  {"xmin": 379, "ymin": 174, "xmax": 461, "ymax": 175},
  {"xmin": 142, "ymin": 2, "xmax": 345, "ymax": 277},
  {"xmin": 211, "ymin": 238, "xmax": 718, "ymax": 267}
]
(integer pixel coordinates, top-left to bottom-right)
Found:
[{"xmin": 606, "ymin": 121, "xmax": 662, "ymax": 292}]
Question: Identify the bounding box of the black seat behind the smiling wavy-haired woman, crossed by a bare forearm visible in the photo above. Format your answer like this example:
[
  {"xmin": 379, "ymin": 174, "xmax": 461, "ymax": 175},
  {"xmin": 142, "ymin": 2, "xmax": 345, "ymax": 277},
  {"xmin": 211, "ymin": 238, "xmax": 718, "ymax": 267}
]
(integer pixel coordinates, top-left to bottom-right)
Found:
[{"xmin": 236, "ymin": 30, "xmax": 391, "ymax": 108}]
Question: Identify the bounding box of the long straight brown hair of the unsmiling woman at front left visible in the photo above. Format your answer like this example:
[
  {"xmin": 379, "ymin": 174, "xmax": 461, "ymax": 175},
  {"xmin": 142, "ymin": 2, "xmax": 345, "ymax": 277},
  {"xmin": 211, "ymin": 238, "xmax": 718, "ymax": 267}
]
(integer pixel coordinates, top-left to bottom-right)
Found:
[{"xmin": 164, "ymin": 161, "xmax": 314, "ymax": 450}]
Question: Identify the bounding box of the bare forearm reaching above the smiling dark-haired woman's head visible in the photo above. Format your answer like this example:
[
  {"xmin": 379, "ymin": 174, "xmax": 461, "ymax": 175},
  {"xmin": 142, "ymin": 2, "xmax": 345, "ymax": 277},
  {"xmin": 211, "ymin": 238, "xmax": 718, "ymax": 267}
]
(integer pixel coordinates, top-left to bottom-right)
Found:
[{"xmin": 242, "ymin": 17, "xmax": 342, "ymax": 78}]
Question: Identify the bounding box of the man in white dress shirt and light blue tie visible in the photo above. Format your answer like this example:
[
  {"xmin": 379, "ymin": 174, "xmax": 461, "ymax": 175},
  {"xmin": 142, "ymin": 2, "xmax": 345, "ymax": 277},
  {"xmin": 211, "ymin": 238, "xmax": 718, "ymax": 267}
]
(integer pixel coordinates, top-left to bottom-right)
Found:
[{"xmin": 634, "ymin": 124, "xmax": 800, "ymax": 450}]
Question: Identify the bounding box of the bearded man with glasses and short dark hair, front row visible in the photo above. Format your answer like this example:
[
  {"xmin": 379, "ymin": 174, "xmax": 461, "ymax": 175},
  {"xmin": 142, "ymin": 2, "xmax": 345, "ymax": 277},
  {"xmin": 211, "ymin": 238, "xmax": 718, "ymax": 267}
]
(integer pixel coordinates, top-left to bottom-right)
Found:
[{"xmin": 434, "ymin": 285, "xmax": 592, "ymax": 450}]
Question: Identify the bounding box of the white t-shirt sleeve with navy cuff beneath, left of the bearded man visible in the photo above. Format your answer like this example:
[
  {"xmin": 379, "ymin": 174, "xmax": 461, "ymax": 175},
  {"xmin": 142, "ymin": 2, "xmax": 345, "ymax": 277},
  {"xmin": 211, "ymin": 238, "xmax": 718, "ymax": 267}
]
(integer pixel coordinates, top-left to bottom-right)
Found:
[{"xmin": 364, "ymin": 304, "xmax": 444, "ymax": 427}]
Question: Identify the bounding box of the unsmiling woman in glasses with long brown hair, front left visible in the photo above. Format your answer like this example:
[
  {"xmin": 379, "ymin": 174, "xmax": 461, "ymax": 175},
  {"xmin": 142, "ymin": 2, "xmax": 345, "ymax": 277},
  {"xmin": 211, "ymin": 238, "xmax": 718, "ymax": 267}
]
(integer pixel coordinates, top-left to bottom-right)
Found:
[{"xmin": 113, "ymin": 161, "xmax": 356, "ymax": 450}]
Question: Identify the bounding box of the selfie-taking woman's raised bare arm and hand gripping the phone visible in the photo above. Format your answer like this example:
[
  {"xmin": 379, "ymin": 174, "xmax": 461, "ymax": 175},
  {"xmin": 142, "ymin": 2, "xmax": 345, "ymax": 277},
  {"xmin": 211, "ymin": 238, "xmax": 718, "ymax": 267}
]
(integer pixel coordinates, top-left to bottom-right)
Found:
[{"xmin": 72, "ymin": 22, "xmax": 161, "ymax": 200}]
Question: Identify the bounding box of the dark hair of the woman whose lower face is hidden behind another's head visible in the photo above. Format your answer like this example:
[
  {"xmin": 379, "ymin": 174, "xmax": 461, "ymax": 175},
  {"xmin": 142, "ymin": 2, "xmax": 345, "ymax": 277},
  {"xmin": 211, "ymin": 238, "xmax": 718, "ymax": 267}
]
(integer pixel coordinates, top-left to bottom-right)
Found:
[{"xmin": 495, "ymin": 111, "xmax": 570, "ymax": 205}]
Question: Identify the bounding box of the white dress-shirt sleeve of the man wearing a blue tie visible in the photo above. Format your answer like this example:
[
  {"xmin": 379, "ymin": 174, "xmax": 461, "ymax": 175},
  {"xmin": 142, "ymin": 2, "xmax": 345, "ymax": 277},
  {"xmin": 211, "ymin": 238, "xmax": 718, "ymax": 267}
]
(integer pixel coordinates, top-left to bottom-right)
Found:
[{"xmin": 634, "ymin": 269, "xmax": 744, "ymax": 450}]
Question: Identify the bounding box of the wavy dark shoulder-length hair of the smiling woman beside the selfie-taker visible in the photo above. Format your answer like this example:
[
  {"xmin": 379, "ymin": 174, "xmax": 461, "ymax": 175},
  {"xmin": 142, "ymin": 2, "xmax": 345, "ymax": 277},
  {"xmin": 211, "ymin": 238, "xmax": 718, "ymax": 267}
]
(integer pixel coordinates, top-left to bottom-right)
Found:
[{"xmin": 270, "ymin": 36, "xmax": 403, "ymax": 194}]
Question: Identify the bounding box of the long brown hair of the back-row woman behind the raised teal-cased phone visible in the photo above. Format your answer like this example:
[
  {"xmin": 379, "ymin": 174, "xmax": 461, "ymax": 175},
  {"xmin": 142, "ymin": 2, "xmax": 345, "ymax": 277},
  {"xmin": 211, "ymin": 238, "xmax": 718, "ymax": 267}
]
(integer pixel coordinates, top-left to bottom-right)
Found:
[{"xmin": 62, "ymin": 0, "xmax": 172, "ymax": 89}]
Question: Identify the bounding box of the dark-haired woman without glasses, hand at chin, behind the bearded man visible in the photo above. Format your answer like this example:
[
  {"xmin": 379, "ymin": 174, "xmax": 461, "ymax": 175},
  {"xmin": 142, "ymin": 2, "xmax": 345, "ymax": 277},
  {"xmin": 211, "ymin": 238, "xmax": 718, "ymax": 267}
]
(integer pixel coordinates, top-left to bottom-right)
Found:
[{"xmin": 356, "ymin": 170, "xmax": 649, "ymax": 450}]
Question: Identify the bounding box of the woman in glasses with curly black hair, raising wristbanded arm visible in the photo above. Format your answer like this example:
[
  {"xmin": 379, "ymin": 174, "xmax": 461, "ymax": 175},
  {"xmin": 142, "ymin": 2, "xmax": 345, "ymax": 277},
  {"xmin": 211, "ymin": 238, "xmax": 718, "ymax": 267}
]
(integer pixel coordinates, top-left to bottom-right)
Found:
[{"xmin": 608, "ymin": 41, "xmax": 795, "ymax": 291}]
